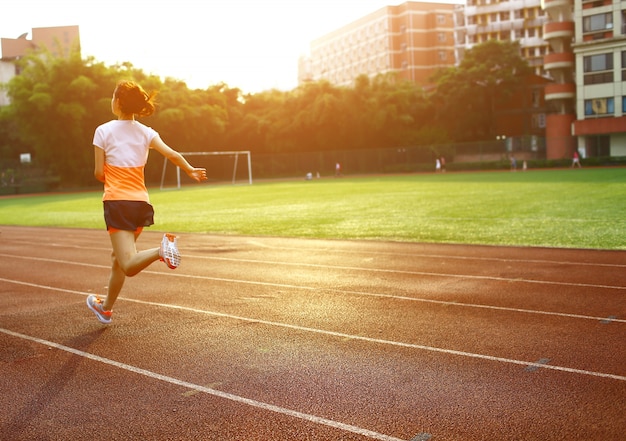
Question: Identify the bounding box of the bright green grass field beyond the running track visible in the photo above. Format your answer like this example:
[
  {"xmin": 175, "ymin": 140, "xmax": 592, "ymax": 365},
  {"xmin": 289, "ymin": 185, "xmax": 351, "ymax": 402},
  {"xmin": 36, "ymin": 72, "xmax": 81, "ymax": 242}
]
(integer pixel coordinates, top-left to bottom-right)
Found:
[{"xmin": 0, "ymin": 168, "xmax": 626, "ymax": 250}]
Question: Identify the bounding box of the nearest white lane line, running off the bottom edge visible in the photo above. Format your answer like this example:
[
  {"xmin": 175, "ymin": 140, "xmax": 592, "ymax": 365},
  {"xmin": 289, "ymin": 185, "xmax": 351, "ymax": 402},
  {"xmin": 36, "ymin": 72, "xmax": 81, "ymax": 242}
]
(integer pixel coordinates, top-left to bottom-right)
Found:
[{"xmin": 0, "ymin": 328, "xmax": 403, "ymax": 441}]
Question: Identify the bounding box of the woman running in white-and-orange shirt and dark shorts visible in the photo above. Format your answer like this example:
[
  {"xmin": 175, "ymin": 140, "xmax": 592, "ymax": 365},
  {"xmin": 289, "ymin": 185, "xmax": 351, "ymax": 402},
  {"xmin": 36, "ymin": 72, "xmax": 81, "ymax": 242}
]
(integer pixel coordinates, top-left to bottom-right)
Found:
[{"xmin": 87, "ymin": 81, "xmax": 206, "ymax": 324}]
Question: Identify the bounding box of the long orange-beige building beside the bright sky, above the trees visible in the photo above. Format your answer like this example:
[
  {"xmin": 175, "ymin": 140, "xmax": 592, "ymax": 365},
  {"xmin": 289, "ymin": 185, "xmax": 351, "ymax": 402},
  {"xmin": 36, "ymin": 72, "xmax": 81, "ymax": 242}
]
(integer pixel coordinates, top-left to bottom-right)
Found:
[{"xmin": 299, "ymin": 2, "xmax": 455, "ymax": 86}]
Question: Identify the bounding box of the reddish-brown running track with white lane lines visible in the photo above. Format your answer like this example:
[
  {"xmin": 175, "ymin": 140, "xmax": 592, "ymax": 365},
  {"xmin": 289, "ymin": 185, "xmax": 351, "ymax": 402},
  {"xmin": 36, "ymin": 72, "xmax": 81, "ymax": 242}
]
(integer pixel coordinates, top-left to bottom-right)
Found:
[{"xmin": 0, "ymin": 226, "xmax": 626, "ymax": 441}]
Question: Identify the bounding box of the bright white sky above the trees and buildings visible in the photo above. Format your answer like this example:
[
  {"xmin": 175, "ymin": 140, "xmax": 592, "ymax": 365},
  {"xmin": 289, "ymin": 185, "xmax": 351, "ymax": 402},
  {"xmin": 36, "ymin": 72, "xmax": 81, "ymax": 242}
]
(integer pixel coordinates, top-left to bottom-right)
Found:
[{"xmin": 0, "ymin": 0, "xmax": 459, "ymax": 93}]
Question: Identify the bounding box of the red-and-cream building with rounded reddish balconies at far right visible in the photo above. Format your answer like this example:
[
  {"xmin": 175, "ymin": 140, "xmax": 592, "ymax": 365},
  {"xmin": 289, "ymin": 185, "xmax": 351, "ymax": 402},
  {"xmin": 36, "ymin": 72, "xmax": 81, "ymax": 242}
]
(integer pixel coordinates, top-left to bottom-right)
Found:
[{"xmin": 543, "ymin": 0, "xmax": 626, "ymax": 158}]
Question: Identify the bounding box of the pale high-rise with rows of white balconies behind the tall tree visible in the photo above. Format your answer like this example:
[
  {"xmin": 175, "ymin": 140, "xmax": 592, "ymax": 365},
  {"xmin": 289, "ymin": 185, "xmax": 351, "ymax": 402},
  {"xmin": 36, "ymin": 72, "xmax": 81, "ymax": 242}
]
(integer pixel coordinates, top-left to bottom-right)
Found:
[{"xmin": 454, "ymin": 0, "xmax": 548, "ymax": 76}]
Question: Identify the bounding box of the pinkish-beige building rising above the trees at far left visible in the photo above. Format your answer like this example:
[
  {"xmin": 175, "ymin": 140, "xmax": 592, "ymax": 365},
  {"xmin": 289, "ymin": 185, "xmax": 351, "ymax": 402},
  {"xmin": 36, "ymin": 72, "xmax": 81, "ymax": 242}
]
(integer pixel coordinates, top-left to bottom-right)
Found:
[{"xmin": 0, "ymin": 26, "xmax": 80, "ymax": 106}]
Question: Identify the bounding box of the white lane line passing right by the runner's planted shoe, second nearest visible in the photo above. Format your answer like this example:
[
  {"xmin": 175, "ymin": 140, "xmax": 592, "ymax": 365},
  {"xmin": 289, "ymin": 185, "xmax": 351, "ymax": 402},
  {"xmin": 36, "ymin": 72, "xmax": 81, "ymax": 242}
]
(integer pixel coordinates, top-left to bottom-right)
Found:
[{"xmin": 0, "ymin": 278, "xmax": 626, "ymax": 381}]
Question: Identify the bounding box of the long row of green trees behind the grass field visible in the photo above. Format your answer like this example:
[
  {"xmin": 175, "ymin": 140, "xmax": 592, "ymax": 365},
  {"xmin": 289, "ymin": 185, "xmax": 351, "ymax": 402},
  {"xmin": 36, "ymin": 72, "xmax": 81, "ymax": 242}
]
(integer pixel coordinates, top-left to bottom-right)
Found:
[{"xmin": 0, "ymin": 39, "xmax": 525, "ymax": 187}]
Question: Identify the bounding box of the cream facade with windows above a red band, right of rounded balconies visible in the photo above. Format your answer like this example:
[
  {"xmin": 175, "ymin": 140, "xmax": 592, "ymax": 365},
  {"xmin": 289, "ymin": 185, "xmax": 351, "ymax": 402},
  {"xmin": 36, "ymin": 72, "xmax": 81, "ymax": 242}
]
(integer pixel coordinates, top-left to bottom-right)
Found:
[{"xmin": 572, "ymin": 0, "xmax": 626, "ymax": 157}]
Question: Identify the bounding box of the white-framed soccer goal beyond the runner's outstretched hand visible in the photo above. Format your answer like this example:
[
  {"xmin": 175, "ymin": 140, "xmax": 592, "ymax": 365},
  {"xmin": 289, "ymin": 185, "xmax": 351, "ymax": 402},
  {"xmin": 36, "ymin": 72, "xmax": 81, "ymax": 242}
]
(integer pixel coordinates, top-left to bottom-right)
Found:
[{"xmin": 161, "ymin": 151, "xmax": 252, "ymax": 190}]
